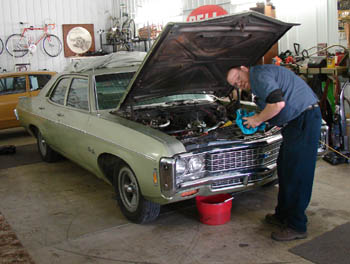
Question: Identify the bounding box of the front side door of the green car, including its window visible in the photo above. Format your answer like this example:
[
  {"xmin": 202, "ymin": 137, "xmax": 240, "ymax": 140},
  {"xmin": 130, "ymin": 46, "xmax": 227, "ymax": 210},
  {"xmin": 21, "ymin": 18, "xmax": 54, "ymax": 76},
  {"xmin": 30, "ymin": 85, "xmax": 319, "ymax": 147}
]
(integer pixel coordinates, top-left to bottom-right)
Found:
[{"xmin": 53, "ymin": 76, "xmax": 90, "ymax": 164}]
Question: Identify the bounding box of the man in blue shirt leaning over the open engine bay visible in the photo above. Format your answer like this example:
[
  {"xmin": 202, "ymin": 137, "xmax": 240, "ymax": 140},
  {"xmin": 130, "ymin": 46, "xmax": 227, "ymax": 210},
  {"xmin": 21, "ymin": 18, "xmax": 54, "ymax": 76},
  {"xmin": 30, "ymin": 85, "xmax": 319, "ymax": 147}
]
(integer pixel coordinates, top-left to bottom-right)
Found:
[{"xmin": 227, "ymin": 65, "xmax": 321, "ymax": 241}]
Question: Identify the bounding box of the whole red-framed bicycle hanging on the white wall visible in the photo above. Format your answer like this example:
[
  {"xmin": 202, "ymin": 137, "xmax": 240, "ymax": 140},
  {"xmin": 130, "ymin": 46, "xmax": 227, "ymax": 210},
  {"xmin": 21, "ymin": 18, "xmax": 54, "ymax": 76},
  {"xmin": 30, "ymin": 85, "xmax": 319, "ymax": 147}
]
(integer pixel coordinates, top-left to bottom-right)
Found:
[{"xmin": 5, "ymin": 22, "xmax": 62, "ymax": 58}]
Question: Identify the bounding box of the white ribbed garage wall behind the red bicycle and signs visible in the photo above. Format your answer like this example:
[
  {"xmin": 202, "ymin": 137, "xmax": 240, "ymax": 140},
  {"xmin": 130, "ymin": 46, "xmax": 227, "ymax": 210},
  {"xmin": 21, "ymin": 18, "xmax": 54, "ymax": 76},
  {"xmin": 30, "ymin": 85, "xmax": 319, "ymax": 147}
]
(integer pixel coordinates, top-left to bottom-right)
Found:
[{"xmin": 0, "ymin": 0, "xmax": 344, "ymax": 71}]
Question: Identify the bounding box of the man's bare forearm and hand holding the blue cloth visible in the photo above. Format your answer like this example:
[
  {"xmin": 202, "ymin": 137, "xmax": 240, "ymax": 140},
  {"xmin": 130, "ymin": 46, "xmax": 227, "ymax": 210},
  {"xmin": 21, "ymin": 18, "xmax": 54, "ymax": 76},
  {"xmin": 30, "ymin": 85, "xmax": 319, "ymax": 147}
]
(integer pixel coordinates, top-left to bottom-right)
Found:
[{"xmin": 242, "ymin": 101, "xmax": 285, "ymax": 128}]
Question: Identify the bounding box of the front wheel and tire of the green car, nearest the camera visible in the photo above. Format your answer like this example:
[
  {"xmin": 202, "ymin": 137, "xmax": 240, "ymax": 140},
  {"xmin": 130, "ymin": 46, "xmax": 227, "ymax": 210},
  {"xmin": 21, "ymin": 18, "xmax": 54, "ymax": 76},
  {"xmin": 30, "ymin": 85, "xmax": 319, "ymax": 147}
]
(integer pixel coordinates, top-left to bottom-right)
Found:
[{"xmin": 113, "ymin": 164, "xmax": 160, "ymax": 224}]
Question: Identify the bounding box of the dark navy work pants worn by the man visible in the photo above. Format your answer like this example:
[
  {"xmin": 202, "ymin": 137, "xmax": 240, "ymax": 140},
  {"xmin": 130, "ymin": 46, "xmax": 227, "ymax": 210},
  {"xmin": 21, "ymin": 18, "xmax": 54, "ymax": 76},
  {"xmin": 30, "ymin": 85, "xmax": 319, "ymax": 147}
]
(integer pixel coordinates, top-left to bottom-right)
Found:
[{"xmin": 276, "ymin": 107, "xmax": 321, "ymax": 232}]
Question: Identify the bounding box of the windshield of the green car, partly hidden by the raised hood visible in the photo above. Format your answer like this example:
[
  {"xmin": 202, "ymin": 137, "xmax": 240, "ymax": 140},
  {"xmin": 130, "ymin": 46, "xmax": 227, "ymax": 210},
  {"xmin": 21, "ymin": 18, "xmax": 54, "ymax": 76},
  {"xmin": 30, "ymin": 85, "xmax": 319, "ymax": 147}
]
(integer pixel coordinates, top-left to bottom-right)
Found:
[{"xmin": 95, "ymin": 72, "xmax": 134, "ymax": 110}]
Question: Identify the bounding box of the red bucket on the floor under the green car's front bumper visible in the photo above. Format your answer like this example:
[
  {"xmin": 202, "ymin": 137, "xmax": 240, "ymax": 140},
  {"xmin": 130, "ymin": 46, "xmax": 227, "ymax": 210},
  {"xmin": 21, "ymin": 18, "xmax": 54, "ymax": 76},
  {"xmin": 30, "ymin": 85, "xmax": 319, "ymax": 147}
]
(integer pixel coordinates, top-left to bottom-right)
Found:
[{"xmin": 196, "ymin": 193, "xmax": 233, "ymax": 225}]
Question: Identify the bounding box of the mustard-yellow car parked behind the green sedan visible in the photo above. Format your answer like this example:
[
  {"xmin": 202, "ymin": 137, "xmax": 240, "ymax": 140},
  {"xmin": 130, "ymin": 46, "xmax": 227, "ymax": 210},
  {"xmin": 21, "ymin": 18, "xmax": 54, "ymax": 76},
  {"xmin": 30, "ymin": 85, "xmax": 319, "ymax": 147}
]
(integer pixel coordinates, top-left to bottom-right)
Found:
[{"xmin": 0, "ymin": 71, "xmax": 56, "ymax": 129}]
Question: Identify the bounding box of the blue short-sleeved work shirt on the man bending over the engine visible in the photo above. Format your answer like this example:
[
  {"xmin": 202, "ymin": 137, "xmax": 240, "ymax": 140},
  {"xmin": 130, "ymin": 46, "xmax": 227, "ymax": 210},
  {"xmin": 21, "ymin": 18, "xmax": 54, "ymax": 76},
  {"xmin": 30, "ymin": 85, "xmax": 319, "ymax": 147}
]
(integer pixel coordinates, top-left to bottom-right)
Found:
[{"xmin": 249, "ymin": 64, "xmax": 318, "ymax": 126}]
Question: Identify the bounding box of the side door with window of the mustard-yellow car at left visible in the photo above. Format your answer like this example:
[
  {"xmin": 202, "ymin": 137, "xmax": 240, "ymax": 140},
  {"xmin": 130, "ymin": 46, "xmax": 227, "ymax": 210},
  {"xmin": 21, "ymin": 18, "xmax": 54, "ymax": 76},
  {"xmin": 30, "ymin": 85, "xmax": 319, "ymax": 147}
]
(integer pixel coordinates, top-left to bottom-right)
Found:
[{"xmin": 0, "ymin": 74, "xmax": 29, "ymax": 129}]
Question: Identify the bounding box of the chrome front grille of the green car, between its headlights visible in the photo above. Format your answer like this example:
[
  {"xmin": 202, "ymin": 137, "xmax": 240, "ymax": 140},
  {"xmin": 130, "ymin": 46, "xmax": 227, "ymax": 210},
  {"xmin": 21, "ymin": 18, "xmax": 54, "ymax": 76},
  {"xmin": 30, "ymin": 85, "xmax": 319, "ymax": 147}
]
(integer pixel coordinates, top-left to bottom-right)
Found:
[{"xmin": 206, "ymin": 141, "xmax": 281, "ymax": 172}]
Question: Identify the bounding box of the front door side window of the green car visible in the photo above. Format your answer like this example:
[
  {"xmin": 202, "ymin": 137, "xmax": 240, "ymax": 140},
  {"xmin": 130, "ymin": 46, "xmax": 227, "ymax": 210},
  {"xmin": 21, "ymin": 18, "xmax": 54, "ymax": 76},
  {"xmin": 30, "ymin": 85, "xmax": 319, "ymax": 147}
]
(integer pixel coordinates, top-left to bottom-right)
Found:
[{"xmin": 67, "ymin": 78, "xmax": 89, "ymax": 110}]
